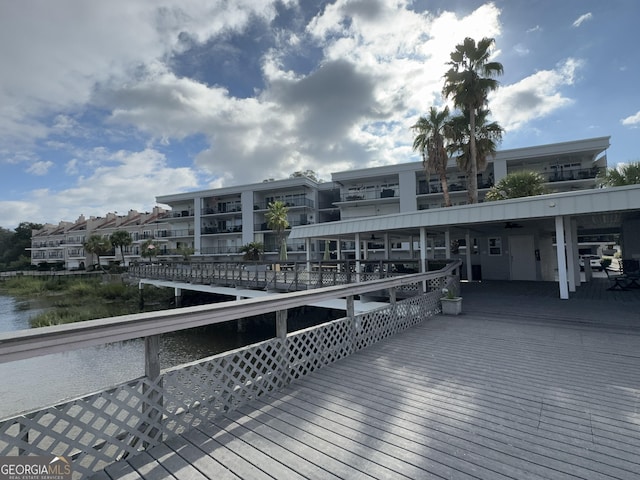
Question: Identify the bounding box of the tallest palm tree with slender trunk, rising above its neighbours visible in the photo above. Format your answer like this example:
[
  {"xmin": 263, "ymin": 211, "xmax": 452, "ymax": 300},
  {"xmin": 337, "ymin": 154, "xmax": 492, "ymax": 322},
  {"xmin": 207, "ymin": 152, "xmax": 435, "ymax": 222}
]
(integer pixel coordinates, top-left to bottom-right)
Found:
[{"xmin": 442, "ymin": 37, "xmax": 503, "ymax": 203}]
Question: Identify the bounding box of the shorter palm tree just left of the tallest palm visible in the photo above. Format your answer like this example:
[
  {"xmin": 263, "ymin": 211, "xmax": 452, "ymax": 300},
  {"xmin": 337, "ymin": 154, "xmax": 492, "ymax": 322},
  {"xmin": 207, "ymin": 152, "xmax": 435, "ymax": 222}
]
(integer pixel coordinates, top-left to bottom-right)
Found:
[{"xmin": 411, "ymin": 107, "xmax": 451, "ymax": 207}]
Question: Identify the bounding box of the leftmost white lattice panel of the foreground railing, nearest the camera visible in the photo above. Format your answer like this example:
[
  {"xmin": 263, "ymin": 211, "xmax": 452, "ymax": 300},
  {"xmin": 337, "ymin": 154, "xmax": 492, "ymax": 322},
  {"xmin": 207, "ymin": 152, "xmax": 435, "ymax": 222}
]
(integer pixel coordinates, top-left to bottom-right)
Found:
[{"xmin": 0, "ymin": 378, "xmax": 162, "ymax": 478}]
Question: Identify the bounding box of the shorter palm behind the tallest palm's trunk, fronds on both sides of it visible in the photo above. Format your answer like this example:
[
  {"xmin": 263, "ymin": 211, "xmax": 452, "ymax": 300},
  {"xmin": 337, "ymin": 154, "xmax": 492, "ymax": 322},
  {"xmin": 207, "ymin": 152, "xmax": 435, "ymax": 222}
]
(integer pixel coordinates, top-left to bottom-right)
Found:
[{"xmin": 448, "ymin": 109, "xmax": 504, "ymax": 203}]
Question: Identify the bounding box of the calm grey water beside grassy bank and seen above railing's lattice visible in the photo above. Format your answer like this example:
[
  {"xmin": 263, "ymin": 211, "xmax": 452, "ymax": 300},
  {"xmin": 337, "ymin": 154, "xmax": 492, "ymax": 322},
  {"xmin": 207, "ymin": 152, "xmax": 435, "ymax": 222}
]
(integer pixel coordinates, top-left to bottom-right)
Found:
[{"xmin": 0, "ymin": 295, "xmax": 266, "ymax": 419}]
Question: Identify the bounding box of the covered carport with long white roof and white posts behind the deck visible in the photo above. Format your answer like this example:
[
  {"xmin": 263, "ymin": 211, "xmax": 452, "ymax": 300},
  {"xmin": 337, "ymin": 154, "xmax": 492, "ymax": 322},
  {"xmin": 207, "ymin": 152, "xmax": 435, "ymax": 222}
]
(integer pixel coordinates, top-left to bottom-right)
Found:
[{"xmin": 290, "ymin": 185, "xmax": 640, "ymax": 299}]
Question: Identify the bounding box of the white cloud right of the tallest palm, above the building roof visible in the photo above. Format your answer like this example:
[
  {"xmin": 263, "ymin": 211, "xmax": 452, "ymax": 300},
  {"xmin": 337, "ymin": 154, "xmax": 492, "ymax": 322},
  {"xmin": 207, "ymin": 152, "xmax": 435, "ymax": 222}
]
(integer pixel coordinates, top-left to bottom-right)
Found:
[{"xmin": 490, "ymin": 58, "xmax": 583, "ymax": 131}]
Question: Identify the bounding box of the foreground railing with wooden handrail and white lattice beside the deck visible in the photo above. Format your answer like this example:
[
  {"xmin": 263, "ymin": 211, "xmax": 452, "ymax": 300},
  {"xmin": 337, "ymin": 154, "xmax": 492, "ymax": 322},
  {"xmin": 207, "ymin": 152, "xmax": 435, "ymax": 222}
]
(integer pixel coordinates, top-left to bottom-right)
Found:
[{"xmin": 0, "ymin": 264, "xmax": 459, "ymax": 478}]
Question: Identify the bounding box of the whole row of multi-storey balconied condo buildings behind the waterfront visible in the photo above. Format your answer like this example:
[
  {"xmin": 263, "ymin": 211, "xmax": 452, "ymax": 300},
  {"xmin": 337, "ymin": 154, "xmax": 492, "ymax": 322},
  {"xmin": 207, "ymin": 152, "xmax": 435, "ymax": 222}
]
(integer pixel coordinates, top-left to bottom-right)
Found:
[{"xmin": 31, "ymin": 137, "xmax": 610, "ymax": 268}]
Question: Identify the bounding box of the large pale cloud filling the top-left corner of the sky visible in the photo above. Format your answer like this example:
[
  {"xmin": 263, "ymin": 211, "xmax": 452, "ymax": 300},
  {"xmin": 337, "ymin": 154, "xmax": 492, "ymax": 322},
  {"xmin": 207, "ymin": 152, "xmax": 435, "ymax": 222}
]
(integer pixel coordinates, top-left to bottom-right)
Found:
[{"xmin": 0, "ymin": 0, "xmax": 291, "ymax": 153}]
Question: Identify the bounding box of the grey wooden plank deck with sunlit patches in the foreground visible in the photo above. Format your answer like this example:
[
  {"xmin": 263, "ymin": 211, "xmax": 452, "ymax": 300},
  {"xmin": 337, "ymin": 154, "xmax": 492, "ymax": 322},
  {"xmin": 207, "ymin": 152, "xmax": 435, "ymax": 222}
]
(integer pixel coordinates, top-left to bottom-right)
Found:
[{"xmin": 96, "ymin": 284, "xmax": 640, "ymax": 480}]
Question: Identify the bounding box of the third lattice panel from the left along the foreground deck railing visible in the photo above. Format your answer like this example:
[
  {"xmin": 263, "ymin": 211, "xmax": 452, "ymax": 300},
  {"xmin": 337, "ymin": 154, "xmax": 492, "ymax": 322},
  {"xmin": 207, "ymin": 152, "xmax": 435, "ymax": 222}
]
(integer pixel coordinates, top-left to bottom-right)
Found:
[{"xmin": 287, "ymin": 318, "xmax": 355, "ymax": 378}]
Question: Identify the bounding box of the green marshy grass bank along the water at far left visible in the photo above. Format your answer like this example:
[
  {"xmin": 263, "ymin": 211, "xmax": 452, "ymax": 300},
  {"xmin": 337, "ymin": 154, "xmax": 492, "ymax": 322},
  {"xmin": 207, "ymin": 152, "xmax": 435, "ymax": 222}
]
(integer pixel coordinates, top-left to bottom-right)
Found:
[{"xmin": 0, "ymin": 276, "xmax": 173, "ymax": 327}]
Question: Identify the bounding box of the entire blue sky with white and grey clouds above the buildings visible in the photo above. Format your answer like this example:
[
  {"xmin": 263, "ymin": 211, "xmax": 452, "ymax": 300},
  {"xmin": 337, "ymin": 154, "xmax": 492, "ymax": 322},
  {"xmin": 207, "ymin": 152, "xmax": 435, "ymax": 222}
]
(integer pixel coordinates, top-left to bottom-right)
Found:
[{"xmin": 0, "ymin": 0, "xmax": 640, "ymax": 228}]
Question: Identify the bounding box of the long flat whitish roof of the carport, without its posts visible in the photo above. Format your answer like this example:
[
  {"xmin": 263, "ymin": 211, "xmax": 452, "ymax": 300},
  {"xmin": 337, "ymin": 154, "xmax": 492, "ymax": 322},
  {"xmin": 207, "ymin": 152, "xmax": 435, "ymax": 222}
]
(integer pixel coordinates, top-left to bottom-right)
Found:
[{"xmin": 289, "ymin": 185, "xmax": 640, "ymax": 238}]
